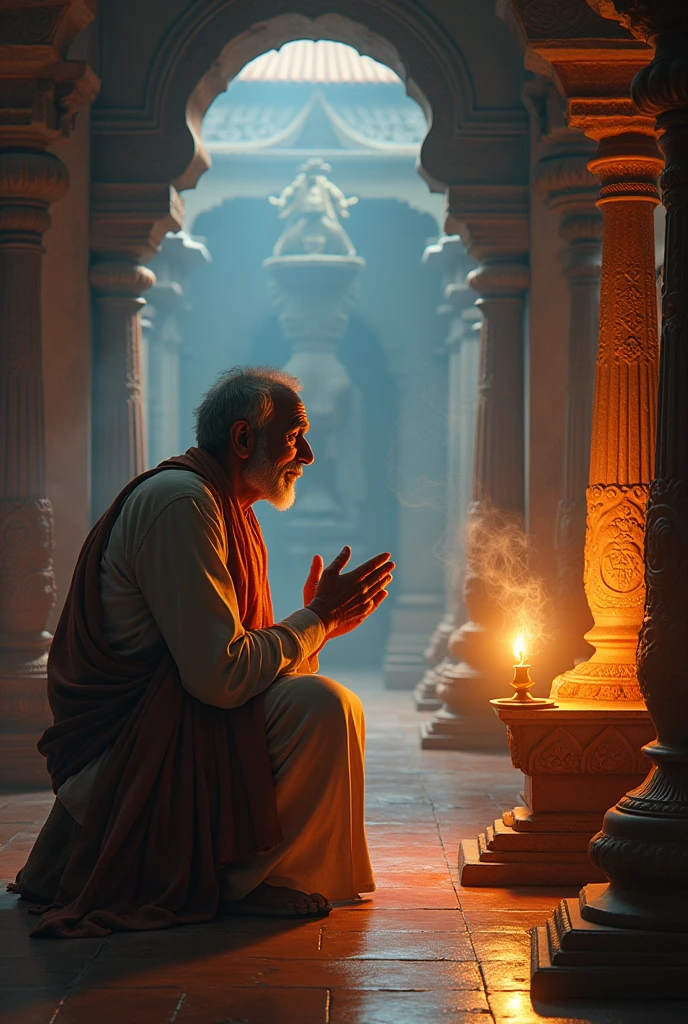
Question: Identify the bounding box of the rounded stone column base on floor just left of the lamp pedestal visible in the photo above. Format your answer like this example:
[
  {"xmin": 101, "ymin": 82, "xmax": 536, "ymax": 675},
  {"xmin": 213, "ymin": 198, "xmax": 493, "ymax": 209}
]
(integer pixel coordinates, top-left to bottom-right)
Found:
[{"xmin": 421, "ymin": 662, "xmax": 506, "ymax": 751}]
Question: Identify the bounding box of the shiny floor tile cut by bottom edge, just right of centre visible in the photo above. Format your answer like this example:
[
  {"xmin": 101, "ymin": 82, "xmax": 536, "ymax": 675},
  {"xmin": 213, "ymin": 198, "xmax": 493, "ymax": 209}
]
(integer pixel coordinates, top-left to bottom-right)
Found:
[{"xmin": 330, "ymin": 989, "xmax": 491, "ymax": 1024}]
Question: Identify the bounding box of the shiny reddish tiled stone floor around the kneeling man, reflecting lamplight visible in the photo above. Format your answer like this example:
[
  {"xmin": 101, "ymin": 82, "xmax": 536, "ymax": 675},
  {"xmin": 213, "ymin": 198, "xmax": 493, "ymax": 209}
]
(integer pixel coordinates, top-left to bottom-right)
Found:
[{"xmin": 0, "ymin": 674, "xmax": 688, "ymax": 1024}]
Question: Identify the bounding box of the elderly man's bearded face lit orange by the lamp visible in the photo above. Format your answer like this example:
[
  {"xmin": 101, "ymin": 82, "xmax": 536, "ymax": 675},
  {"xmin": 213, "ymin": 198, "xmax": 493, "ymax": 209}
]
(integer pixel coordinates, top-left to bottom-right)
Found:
[{"xmin": 246, "ymin": 391, "xmax": 313, "ymax": 511}]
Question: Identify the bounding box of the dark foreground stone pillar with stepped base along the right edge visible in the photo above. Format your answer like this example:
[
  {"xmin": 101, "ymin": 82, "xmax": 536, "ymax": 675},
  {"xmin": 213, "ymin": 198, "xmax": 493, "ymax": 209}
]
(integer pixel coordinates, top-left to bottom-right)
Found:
[{"xmin": 531, "ymin": 0, "xmax": 688, "ymax": 998}]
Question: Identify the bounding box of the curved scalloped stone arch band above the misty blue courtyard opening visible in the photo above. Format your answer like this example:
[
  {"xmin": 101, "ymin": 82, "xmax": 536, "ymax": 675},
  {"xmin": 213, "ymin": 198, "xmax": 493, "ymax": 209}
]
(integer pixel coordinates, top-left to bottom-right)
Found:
[{"xmin": 137, "ymin": 0, "xmax": 475, "ymax": 190}]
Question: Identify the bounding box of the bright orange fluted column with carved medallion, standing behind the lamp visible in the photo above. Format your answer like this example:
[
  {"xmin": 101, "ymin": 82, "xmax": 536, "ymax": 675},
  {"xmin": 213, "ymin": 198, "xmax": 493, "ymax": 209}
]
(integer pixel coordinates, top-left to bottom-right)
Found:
[{"xmin": 552, "ymin": 132, "xmax": 661, "ymax": 700}]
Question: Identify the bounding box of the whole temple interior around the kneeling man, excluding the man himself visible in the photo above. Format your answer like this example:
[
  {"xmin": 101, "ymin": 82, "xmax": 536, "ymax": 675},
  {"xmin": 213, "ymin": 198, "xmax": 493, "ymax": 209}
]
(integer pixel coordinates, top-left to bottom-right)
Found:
[{"xmin": 0, "ymin": 0, "xmax": 688, "ymax": 1024}]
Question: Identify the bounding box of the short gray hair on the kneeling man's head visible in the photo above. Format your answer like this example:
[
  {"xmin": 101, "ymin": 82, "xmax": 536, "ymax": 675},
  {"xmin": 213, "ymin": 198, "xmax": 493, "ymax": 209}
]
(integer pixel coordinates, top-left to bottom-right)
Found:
[{"xmin": 194, "ymin": 367, "xmax": 301, "ymax": 452}]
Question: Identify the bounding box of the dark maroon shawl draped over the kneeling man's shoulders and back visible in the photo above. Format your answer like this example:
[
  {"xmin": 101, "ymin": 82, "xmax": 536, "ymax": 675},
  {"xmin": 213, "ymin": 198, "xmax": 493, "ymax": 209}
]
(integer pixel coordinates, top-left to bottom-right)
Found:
[{"xmin": 33, "ymin": 449, "xmax": 282, "ymax": 937}]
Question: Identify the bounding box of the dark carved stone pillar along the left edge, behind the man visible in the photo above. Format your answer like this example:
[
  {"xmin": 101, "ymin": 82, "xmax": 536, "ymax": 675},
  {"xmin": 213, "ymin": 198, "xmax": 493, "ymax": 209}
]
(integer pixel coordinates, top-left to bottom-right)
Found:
[{"xmin": 0, "ymin": 2, "xmax": 98, "ymax": 786}]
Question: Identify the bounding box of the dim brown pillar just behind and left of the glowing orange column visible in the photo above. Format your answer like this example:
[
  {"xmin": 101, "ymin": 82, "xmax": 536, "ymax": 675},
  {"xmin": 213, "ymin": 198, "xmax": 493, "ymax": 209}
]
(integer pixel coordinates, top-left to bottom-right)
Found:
[{"xmin": 533, "ymin": 149, "xmax": 602, "ymax": 665}]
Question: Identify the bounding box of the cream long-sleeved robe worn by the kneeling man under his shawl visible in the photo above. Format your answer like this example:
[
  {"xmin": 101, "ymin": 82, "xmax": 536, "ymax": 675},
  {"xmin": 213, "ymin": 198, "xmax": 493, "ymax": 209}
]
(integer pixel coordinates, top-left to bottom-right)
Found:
[{"xmin": 57, "ymin": 469, "xmax": 375, "ymax": 900}]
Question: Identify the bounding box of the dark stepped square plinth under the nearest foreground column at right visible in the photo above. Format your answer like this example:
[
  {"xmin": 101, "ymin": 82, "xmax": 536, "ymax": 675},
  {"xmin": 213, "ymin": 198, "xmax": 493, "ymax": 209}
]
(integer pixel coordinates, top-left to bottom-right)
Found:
[{"xmin": 530, "ymin": 885, "xmax": 688, "ymax": 1002}]
